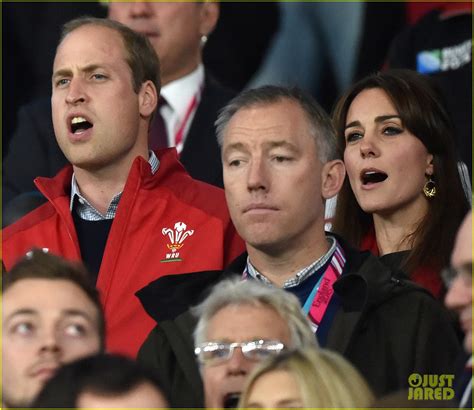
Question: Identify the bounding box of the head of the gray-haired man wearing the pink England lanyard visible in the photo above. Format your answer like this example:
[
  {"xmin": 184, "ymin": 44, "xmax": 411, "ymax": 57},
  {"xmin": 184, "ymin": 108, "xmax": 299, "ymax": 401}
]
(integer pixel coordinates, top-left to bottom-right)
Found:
[{"xmin": 216, "ymin": 86, "xmax": 345, "ymax": 262}]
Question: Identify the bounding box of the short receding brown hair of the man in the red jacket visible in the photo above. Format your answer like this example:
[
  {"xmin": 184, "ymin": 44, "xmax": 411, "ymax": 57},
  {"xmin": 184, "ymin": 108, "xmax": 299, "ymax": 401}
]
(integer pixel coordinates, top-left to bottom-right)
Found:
[{"xmin": 59, "ymin": 17, "xmax": 161, "ymax": 94}]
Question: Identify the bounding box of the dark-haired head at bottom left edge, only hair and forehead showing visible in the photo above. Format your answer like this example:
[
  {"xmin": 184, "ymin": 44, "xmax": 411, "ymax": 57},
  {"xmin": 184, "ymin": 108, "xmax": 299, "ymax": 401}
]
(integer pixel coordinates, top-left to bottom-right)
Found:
[{"xmin": 34, "ymin": 355, "xmax": 168, "ymax": 408}]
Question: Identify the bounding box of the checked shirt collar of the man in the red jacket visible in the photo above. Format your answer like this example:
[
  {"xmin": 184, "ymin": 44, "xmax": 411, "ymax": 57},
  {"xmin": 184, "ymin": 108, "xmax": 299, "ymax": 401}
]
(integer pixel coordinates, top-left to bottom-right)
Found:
[{"xmin": 69, "ymin": 151, "xmax": 160, "ymax": 221}]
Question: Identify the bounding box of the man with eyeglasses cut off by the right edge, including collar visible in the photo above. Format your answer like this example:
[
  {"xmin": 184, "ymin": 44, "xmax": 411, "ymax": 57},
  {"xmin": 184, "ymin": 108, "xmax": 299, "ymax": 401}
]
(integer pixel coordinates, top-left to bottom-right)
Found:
[{"xmin": 443, "ymin": 211, "xmax": 472, "ymax": 409}]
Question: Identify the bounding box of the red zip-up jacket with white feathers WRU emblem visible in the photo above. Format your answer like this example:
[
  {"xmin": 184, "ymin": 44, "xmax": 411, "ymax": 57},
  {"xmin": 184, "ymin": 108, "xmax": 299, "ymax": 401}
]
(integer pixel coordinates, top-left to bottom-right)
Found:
[{"xmin": 2, "ymin": 148, "xmax": 244, "ymax": 357}]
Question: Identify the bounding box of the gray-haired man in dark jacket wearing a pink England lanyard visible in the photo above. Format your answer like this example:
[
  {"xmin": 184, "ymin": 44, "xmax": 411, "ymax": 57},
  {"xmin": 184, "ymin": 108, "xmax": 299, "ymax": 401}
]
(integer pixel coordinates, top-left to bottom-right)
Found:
[{"xmin": 139, "ymin": 86, "xmax": 460, "ymax": 407}]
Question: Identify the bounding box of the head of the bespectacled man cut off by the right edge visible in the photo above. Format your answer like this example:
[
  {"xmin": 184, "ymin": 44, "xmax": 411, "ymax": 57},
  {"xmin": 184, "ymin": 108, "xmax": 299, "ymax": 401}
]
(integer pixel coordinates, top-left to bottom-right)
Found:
[{"xmin": 443, "ymin": 211, "xmax": 473, "ymax": 353}]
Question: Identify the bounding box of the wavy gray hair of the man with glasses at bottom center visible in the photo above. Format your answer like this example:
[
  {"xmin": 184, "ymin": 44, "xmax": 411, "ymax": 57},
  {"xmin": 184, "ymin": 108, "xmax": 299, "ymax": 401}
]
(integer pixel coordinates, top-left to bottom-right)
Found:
[{"xmin": 193, "ymin": 279, "xmax": 317, "ymax": 348}]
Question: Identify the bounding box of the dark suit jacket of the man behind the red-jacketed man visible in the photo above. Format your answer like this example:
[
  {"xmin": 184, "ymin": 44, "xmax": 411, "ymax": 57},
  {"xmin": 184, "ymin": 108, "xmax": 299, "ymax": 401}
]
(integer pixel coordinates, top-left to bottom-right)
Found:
[{"xmin": 3, "ymin": 74, "xmax": 235, "ymax": 204}]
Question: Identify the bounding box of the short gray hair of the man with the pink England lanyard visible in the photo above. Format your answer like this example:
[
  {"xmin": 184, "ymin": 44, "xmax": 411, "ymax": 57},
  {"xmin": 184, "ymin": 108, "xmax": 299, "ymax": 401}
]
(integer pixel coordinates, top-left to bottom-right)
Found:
[{"xmin": 215, "ymin": 85, "xmax": 341, "ymax": 164}]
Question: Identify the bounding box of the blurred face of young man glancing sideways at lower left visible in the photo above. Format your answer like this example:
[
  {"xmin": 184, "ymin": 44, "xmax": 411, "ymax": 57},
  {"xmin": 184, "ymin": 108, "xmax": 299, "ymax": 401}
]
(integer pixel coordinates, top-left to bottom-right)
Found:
[{"xmin": 2, "ymin": 279, "xmax": 101, "ymax": 407}]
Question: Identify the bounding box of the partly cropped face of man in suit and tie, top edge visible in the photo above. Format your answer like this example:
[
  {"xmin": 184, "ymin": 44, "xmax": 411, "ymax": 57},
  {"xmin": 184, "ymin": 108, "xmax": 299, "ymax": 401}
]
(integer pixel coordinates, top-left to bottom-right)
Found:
[{"xmin": 108, "ymin": 1, "xmax": 219, "ymax": 85}]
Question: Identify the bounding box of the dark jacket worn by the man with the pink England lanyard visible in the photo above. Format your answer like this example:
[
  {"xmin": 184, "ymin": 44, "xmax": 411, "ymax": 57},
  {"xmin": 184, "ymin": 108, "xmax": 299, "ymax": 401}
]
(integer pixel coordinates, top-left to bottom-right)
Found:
[{"xmin": 137, "ymin": 237, "xmax": 461, "ymax": 407}]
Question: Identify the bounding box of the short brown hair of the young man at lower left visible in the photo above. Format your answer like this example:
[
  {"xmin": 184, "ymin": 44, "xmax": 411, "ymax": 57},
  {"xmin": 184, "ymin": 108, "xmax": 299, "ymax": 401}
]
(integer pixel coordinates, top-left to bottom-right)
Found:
[{"xmin": 2, "ymin": 249, "xmax": 105, "ymax": 350}]
